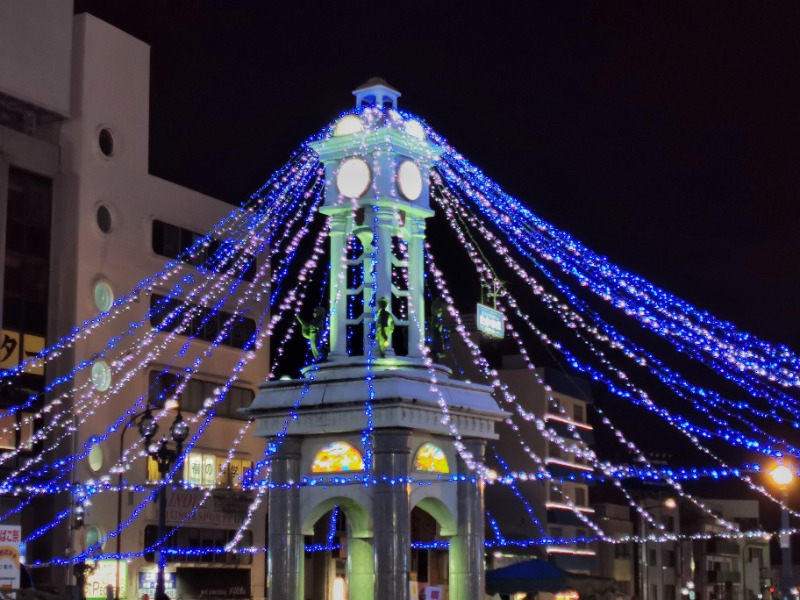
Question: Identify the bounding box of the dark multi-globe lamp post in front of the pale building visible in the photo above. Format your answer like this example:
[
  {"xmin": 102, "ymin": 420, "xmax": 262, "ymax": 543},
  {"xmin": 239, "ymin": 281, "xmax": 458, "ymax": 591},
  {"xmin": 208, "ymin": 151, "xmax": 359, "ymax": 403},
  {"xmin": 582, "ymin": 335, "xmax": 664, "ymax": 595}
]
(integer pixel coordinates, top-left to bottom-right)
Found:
[{"xmin": 139, "ymin": 407, "xmax": 189, "ymax": 600}]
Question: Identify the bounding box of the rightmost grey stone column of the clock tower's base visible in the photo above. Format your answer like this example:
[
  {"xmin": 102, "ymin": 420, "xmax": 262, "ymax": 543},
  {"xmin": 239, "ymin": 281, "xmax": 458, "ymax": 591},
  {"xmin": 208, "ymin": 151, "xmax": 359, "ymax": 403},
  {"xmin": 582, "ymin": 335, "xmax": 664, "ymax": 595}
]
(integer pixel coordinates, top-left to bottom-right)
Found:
[{"xmin": 449, "ymin": 439, "xmax": 486, "ymax": 600}]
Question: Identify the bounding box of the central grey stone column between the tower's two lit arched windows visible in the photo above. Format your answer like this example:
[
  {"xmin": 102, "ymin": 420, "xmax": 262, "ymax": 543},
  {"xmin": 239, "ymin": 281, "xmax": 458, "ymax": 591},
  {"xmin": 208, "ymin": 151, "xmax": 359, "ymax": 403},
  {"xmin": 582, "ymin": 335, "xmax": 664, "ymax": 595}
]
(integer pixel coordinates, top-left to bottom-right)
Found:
[{"xmin": 372, "ymin": 429, "xmax": 411, "ymax": 600}]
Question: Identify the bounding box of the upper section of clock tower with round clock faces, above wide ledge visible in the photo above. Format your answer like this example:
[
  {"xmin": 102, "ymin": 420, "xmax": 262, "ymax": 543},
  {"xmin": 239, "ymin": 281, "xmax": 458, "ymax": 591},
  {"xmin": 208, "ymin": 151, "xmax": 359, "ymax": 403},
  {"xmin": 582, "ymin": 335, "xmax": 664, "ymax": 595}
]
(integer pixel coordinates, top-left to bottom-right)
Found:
[{"xmin": 312, "ymin": 79, "xmax": 441, "ymax": 364}]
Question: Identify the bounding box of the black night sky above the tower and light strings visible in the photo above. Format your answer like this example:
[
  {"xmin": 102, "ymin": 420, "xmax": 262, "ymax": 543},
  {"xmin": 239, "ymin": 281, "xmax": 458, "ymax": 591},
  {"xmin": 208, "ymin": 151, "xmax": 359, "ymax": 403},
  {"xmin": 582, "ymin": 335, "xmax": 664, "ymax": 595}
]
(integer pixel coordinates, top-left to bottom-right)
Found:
[{"xmin": 76, "ymin": 0, "xmax": 800, "ymax": 350}]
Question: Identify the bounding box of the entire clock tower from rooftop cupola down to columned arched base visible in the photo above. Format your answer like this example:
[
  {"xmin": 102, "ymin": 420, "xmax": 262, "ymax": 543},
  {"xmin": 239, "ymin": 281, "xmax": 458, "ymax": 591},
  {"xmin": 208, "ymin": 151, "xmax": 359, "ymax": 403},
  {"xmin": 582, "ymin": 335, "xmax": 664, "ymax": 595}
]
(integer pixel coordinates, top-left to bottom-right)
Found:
[{"xmin": 244, "ymin": 80, "xmax": 505, "ymax": 600}]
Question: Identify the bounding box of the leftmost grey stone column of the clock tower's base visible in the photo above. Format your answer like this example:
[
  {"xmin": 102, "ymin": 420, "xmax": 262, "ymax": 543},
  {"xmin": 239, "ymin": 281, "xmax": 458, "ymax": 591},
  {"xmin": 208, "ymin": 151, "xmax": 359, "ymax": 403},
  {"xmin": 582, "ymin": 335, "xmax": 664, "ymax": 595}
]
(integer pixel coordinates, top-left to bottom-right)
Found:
[{"xmin": 267, "ymin": 436, "xmax": 305, "ymax": 600}]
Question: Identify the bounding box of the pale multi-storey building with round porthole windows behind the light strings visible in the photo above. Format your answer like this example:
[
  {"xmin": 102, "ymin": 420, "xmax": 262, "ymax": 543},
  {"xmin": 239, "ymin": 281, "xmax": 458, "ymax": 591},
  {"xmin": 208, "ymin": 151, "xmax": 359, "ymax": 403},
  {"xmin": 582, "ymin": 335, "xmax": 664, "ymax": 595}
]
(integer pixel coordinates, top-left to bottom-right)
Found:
[{"xmin": 0, "ymin": 5, "xmax": 269, "ymax": 600}]
